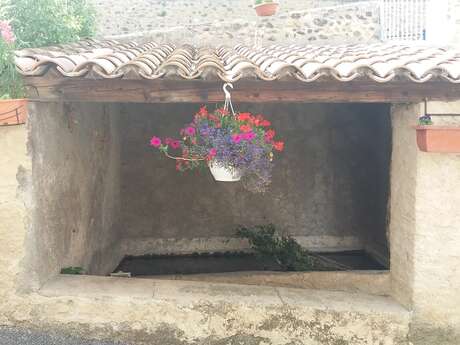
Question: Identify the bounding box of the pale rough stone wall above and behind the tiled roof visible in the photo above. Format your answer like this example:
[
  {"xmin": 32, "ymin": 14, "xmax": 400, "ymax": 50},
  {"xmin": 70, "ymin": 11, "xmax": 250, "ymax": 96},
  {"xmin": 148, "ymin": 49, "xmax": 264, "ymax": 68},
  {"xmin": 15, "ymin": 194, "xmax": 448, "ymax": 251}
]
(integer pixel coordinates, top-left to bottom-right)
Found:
[{"xmin": 94, "ymin": 0, "xmax": 379, "ymax": 45}]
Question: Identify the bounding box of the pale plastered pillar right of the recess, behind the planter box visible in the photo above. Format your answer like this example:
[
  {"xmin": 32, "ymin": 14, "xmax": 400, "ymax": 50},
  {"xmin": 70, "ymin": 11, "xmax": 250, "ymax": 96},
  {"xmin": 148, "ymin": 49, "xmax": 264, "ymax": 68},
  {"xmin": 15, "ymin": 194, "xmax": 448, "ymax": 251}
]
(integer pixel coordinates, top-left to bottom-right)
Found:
[{"xmin": 390, "ymin": 102, "xmax": 460, "ymax": 345}]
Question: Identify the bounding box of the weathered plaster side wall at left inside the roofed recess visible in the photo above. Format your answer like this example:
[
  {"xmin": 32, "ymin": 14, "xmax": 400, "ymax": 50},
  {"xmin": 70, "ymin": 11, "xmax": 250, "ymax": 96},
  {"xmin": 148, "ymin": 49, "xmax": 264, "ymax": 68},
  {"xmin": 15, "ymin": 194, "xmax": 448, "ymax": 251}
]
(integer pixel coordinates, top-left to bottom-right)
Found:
[{"xmin": 23, "ymin": 103, "xmax": 120, "ymax": 284}]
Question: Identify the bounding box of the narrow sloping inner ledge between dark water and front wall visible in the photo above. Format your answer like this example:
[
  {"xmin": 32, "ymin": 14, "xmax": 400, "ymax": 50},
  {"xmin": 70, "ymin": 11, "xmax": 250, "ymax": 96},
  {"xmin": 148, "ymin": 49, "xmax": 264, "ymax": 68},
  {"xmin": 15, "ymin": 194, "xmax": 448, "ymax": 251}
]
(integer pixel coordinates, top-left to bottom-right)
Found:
[{"xmin": 139, "ymin": 271, "xmax": 390, "ymax": 296}]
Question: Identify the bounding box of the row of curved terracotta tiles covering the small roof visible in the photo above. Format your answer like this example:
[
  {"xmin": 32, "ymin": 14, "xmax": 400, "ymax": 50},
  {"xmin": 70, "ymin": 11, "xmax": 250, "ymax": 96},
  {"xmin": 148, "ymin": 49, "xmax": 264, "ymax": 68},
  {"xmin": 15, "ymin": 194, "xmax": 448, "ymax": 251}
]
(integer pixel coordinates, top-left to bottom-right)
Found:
[{"xmin": 12, "ymin": 40, "xmax": 460, "ymax": 83}]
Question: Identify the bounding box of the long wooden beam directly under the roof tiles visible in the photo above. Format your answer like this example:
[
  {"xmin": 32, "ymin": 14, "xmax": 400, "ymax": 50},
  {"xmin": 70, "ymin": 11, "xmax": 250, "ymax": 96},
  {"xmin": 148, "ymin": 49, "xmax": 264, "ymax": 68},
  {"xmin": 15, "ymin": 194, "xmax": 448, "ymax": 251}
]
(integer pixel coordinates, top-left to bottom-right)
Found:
[{"xmin": 26, "ymin": 77, "xmax": 460, "ymax": 103}]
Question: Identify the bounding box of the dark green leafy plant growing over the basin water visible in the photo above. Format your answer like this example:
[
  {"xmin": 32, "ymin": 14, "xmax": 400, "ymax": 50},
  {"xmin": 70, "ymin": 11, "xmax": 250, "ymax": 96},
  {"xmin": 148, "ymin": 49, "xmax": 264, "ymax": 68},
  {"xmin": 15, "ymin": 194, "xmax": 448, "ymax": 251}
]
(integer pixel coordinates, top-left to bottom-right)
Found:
[{"xmin": 237, "ymin": 224, "xmax": 315, "ymax": 271}]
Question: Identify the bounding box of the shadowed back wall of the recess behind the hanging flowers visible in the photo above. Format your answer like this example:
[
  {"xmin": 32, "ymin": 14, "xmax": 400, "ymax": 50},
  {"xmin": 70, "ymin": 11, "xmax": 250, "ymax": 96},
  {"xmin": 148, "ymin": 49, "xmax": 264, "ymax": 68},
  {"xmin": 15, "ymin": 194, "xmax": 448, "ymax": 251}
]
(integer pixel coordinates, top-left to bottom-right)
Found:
[{"xmin": 121, "ymin": 104, "xmax": 391, "ymax": 255}]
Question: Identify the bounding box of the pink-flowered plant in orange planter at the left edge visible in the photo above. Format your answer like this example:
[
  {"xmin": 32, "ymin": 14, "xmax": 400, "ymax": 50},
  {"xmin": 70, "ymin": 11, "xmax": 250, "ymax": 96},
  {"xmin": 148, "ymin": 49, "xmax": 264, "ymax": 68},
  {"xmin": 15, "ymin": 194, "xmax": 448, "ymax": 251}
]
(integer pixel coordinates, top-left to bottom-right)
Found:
[{"xmin": 0, "ymin": 21, "xmax": 27, "ymax": 126}]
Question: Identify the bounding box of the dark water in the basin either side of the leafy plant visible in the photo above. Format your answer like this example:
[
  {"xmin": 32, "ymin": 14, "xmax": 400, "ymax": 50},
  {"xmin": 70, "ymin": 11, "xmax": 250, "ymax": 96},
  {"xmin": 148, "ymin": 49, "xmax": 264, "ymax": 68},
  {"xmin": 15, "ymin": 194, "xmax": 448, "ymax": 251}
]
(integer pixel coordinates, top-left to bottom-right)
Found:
[{"xmin": 115, "ymin": 251, "xmax": 386, "ymax": 276}]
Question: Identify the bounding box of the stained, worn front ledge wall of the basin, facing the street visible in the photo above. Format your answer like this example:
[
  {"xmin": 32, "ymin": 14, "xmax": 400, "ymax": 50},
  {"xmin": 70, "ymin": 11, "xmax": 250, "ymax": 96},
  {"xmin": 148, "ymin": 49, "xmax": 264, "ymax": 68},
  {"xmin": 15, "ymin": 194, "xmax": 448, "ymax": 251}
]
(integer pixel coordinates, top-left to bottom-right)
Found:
[{"xmin": 36, "ymin": 276, "xmax": 410, "ymax": 345}]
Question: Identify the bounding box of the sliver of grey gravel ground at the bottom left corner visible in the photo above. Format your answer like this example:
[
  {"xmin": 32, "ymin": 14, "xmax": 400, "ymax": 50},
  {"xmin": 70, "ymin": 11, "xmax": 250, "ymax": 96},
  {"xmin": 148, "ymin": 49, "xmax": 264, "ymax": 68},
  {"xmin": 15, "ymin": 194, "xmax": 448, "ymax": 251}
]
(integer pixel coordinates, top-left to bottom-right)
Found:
[{"xmin": 0, "ymin": 327, "xmax": 126, "ymax": 345}]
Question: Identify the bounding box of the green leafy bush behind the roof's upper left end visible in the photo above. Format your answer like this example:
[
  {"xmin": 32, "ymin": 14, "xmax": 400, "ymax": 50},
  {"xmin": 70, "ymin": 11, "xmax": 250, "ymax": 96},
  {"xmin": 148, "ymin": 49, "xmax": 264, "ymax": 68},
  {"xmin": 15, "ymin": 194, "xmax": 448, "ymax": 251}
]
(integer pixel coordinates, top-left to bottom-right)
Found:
[{"xmin": 4, "ymin": 0, "xmax": 96, "ymax": 48}]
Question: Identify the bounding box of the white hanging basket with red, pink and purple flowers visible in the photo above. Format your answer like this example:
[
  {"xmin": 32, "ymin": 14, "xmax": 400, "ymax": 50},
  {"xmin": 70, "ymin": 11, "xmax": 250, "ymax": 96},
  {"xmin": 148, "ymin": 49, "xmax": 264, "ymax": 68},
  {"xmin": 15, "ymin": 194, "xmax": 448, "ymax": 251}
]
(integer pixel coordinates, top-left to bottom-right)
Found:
[{"xmin": 150, "ymin": 107, "xmax": 284, "ymax": 192}]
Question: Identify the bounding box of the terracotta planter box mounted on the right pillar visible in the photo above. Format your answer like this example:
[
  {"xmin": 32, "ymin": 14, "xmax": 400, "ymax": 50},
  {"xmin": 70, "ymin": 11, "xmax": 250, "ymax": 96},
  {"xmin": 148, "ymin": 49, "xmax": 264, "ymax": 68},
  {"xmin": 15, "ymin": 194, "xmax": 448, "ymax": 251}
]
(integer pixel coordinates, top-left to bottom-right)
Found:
[{"xmin": 415, "ymin": 125, "xmax": 460, "ymax": 153}]
